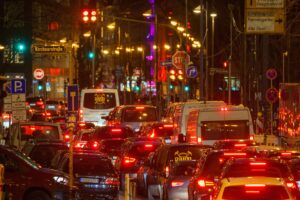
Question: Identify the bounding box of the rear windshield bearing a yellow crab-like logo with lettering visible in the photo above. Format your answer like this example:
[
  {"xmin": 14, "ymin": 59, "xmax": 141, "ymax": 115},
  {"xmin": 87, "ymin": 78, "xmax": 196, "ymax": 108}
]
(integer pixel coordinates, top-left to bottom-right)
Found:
[{"xmin": 167, "ymin": 146, "xmax": 204, "ymax": 163}]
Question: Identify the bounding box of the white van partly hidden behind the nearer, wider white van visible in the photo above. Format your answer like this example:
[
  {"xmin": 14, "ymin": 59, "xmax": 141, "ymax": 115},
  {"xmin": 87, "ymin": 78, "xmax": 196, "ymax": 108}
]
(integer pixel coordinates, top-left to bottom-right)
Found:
[{"xmin": 162, "ymin": 100, "xmax": 226, "ymax": 135}]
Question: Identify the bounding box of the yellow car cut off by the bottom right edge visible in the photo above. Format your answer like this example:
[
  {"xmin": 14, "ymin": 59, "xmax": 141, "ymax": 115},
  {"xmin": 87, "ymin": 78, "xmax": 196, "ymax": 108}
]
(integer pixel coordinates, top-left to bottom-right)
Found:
[{"xmin": 213, "ymin": 177, "xmax": 296, "ymax": 200}]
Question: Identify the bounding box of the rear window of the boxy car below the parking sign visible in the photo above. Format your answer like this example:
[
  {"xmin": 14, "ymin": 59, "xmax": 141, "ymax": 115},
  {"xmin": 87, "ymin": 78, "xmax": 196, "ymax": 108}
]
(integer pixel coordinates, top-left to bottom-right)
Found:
[{"xmin": 21, "ymin": 124, "xmax": 60, "ymax": 140}]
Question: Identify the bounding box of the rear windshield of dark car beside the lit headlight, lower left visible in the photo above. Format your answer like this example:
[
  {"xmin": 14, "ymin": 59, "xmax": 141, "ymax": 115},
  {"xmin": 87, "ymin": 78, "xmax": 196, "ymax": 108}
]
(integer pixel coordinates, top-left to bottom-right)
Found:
[{"xmin": 64, "ymin": 155, "xmax": 115, "ymax": 176}]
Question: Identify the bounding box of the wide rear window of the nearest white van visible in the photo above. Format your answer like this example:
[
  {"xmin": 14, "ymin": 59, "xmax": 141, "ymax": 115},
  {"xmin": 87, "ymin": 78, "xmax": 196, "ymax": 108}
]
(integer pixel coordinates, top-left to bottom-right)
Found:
[{"xmin": 201, "ymin": 121, "xmax": 249, "ymax": 140}]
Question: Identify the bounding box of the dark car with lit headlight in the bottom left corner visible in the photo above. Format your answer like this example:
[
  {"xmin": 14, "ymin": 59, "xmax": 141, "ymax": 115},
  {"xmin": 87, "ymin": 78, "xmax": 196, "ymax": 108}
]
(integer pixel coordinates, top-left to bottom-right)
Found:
[{"xmin": 0, "ymin": 145, "xmax": 70, "ymax": 200}]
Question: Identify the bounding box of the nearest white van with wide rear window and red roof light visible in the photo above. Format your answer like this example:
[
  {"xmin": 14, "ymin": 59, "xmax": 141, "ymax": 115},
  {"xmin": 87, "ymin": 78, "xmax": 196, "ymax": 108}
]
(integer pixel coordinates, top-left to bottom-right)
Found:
[{"xmin": 186, "ymin": 105, "xmax": 254, "ymax": 145}]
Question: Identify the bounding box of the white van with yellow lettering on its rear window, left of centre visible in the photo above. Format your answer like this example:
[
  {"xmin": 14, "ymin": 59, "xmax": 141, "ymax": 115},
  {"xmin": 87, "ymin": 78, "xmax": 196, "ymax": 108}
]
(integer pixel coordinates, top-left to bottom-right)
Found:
[{"xmin": 80, "ymin": 89, "xmax": 120, "ymax": 126}]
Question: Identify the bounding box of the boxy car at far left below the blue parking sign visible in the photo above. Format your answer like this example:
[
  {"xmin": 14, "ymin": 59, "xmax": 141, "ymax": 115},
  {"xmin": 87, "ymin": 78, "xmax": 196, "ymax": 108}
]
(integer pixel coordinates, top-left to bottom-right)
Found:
[{"xmin": 7, "ymin": 121, "xmax": 63, "ymax": 150}]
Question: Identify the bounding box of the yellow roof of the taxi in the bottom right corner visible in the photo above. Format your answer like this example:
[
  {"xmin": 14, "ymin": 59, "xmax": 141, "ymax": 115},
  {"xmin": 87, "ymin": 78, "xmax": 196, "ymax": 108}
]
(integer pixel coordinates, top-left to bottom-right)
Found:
[{"xmin": 221, "ymin": 177, "xmax": 284, "ymax": 187}]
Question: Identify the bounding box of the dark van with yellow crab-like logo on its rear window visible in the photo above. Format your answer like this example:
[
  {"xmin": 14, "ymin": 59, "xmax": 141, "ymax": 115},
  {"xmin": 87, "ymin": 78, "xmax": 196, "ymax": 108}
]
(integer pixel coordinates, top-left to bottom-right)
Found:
[{"xmin": 146, "ymin": 143, "xmax": 211, "ymax": 199}]
